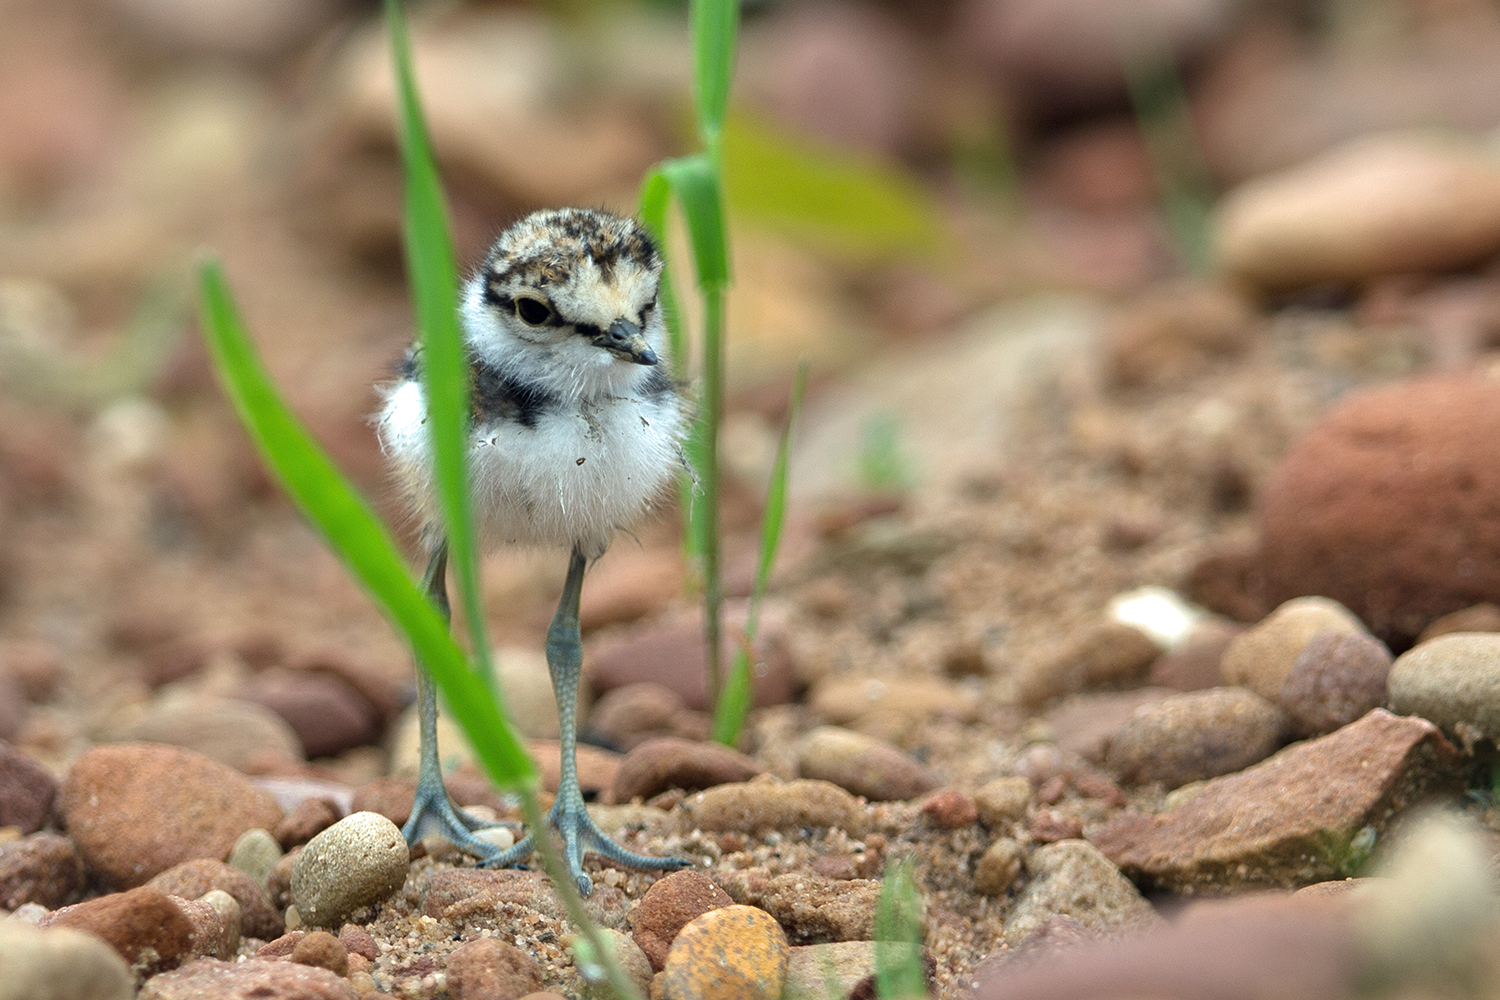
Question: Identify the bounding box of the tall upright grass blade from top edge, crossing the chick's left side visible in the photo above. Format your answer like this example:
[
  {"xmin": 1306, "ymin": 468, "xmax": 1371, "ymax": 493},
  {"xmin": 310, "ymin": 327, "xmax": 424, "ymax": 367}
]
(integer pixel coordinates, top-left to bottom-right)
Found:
[{"xmin": 386, "ymin": 0, "xmax": 500, "ymax": 697}]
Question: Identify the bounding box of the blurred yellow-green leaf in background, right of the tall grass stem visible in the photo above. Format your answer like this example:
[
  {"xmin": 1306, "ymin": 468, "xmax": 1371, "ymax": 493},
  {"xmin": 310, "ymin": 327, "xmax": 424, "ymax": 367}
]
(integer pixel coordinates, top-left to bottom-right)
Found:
[{"xmin": 725, "ymin": 114, "xmax": 948, "ymax": 261}]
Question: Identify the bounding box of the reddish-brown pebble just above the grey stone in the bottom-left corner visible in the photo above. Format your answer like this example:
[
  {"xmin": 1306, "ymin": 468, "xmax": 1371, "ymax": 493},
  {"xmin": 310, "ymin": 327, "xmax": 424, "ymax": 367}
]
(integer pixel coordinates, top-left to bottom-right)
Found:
[{"xmin": 41, "ymin": 886, "xmax": 194, "ymax": 975}]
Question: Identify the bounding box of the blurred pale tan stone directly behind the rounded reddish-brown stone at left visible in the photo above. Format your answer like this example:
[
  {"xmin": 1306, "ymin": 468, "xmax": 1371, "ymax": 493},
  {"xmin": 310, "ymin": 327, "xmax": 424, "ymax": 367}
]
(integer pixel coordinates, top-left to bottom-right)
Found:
[{"xmin": 105, "ymin": 694, "xmax": 303, "ymax": 772}]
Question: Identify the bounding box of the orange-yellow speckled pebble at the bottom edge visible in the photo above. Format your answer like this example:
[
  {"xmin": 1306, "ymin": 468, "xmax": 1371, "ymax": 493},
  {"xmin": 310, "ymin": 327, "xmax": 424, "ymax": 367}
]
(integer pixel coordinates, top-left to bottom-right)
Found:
[{"xmin": 662, "ymin": 906, "xmax": 792, "ymax": 1000}]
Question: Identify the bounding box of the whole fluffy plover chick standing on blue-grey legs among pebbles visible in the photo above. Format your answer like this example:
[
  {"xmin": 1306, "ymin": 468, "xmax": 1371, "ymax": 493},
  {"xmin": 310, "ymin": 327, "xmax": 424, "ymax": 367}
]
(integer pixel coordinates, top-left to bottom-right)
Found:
[{"xmin": 378, "ymin": 208, "xmax": 687, "ymax": 894}]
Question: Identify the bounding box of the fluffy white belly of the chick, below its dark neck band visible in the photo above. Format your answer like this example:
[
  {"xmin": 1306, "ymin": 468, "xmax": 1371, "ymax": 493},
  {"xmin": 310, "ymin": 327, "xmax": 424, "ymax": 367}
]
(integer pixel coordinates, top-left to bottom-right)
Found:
[{"xmin": 380, "ymin": 381, "xmax": 684, "ymax": 558}]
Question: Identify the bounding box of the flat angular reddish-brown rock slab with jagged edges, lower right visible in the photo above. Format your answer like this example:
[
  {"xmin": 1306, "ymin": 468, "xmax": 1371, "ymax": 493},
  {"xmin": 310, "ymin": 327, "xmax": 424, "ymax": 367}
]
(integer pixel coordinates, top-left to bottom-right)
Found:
[{"xmin": 1091, "ymin": 709, "xmax": 1463, "ymax": 892}]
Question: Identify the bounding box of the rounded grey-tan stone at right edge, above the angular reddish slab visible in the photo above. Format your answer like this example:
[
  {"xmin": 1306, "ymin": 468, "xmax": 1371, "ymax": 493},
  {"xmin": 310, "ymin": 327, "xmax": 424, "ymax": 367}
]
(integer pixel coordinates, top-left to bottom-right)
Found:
[{"xmin": 1388, "ymin": 633, "xmax": 1500, "ymax": 747}]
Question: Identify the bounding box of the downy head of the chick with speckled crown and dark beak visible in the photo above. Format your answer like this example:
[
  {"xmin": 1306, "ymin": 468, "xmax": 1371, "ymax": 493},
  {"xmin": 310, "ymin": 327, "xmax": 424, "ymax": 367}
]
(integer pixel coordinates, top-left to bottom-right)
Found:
[{"xmin": 462, "ymin": 208, "xmax": 666, "ymax": 397}]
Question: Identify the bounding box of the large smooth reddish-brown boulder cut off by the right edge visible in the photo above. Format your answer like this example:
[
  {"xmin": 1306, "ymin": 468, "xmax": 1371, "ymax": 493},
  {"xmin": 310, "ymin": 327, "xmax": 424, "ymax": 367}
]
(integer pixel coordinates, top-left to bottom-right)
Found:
[{"xmin": 1260, "ymin": 375, "xmax": 1500, "ymax": 645}]
